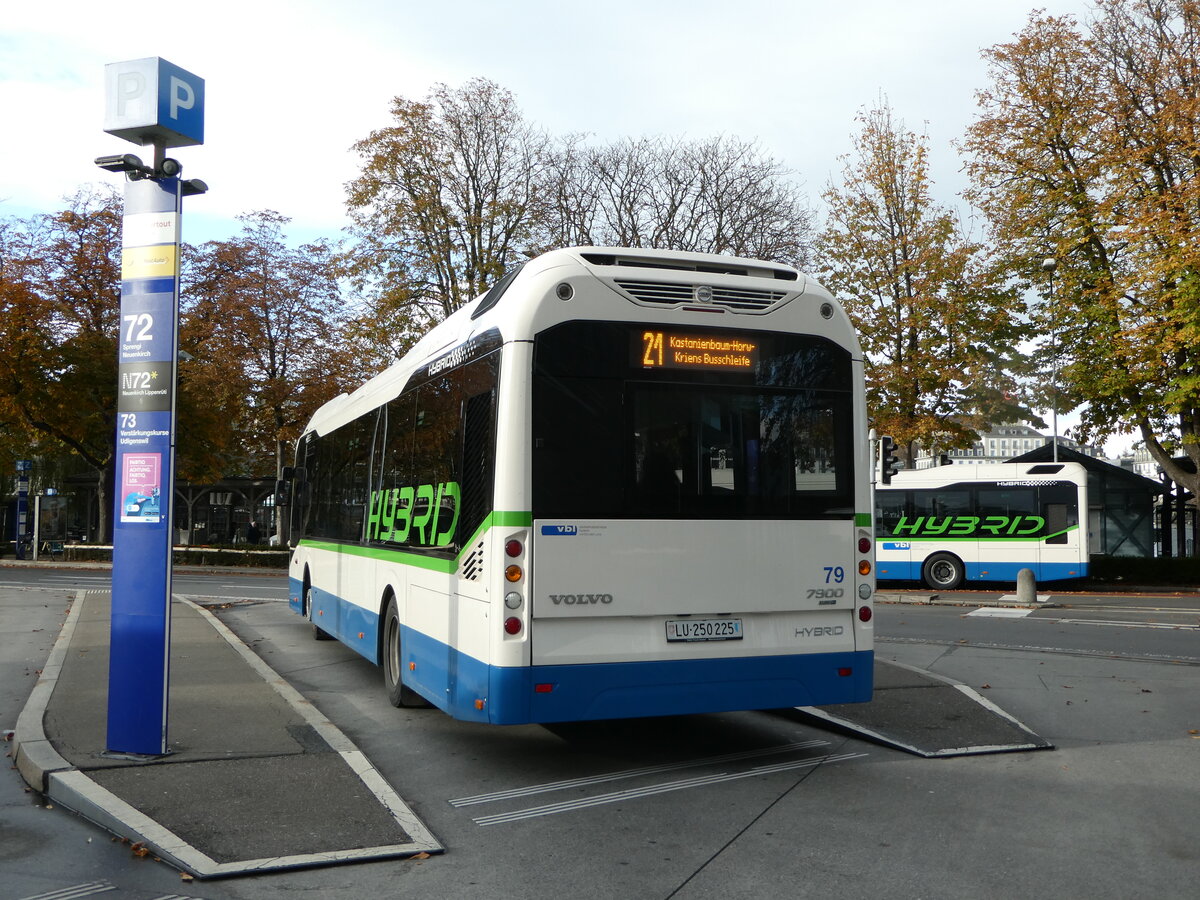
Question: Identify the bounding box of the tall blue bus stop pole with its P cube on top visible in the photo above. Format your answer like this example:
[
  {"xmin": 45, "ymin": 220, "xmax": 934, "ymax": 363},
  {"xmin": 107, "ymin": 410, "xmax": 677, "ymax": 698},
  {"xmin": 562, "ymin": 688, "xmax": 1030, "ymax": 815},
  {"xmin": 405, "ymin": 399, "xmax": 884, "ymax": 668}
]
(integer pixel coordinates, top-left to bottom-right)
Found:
[{"xmin": 96, "ymin": 58, "xmax": 206, "ymax": 756}]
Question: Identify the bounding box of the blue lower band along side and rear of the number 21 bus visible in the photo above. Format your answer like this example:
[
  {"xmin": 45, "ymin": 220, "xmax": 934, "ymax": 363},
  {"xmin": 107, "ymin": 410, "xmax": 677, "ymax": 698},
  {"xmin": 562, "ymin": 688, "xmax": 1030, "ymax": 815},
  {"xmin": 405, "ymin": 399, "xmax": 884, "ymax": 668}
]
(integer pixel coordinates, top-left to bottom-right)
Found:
[{"xmin": 288, "ymin": 580, "xmax": 875, "ymax": 725}]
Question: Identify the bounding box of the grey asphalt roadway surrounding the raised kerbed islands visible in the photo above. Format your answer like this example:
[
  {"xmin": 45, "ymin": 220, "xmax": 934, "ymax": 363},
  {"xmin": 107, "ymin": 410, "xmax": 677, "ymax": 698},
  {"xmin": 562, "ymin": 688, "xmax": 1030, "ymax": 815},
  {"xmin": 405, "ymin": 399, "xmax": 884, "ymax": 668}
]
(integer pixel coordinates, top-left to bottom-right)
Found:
[{"xmin": 0, "ymin": 569, "xmax": 1200, "ymax": 900}]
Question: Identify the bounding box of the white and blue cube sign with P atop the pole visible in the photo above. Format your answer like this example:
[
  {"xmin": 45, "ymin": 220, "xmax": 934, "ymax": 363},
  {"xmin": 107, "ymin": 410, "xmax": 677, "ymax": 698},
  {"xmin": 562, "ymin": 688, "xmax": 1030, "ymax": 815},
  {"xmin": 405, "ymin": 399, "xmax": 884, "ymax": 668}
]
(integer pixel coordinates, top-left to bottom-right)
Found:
[{"xmin": 104, "ymin": 56, "xmax": 204, "ymax": 148}]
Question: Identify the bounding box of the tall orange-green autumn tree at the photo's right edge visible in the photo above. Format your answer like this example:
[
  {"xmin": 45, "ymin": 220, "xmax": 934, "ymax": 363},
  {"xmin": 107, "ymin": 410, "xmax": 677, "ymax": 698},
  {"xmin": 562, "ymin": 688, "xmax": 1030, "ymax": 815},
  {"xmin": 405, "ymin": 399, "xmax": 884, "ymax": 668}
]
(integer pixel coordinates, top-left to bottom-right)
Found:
[{"xmin": 965, "ymin": 0, "xmax": 1200, "ymax": 491}]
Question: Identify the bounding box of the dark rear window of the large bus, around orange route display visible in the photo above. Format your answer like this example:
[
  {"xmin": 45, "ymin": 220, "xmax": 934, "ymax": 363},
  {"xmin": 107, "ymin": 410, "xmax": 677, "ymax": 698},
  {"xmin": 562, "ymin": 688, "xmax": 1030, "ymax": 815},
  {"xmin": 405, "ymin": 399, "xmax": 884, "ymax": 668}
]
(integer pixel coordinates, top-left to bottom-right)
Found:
[{"xmin": 533, "ymin": 323, "xmax": 853, "ymax": 518}]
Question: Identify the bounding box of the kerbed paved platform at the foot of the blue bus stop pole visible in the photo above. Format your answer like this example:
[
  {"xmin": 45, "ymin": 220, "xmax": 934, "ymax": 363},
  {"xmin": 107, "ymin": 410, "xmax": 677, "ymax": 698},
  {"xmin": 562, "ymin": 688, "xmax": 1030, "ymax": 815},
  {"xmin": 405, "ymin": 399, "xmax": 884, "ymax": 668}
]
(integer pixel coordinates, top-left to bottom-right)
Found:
[{"xmin": 13, "ymin": 592, "xmax": 442, "ymax": 877}]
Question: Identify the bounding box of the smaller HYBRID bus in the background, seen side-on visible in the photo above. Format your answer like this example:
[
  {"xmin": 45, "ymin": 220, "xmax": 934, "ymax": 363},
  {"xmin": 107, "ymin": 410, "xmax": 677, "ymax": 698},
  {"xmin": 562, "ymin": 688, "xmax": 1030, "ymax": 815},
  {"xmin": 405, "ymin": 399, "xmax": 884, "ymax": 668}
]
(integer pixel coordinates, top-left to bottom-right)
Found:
[{"xmin": 875, "ymin": 462, "xmax": 1088, "ymax": 590}]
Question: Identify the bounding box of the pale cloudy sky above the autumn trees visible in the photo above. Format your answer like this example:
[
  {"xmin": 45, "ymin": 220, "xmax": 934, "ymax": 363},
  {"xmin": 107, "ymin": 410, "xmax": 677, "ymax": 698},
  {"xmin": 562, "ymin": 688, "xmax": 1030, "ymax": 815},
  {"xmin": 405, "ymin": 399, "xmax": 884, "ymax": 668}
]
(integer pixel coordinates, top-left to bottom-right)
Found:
[{"xmin": 0, "ymin": 0, "xmax": 1123, "ymax": 451}]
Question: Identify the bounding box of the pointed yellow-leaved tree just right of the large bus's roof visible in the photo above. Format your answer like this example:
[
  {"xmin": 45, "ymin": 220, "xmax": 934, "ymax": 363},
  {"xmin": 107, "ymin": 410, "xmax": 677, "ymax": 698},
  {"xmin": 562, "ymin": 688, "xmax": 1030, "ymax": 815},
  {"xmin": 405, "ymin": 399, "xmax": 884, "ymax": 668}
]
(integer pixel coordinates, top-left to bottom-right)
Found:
[{"xmin": 817, "ymin": 102, "xmax": 1028, "ymax": 463}]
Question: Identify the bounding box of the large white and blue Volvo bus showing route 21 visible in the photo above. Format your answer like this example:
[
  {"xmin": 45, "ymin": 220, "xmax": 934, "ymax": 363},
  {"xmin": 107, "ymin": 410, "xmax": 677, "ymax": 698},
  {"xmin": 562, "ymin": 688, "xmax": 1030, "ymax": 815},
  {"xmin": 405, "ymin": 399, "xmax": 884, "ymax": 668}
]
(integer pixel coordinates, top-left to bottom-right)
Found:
[{"xmin": 289, "ymin": 247, "xmax": 875, "ymax": 724}]
